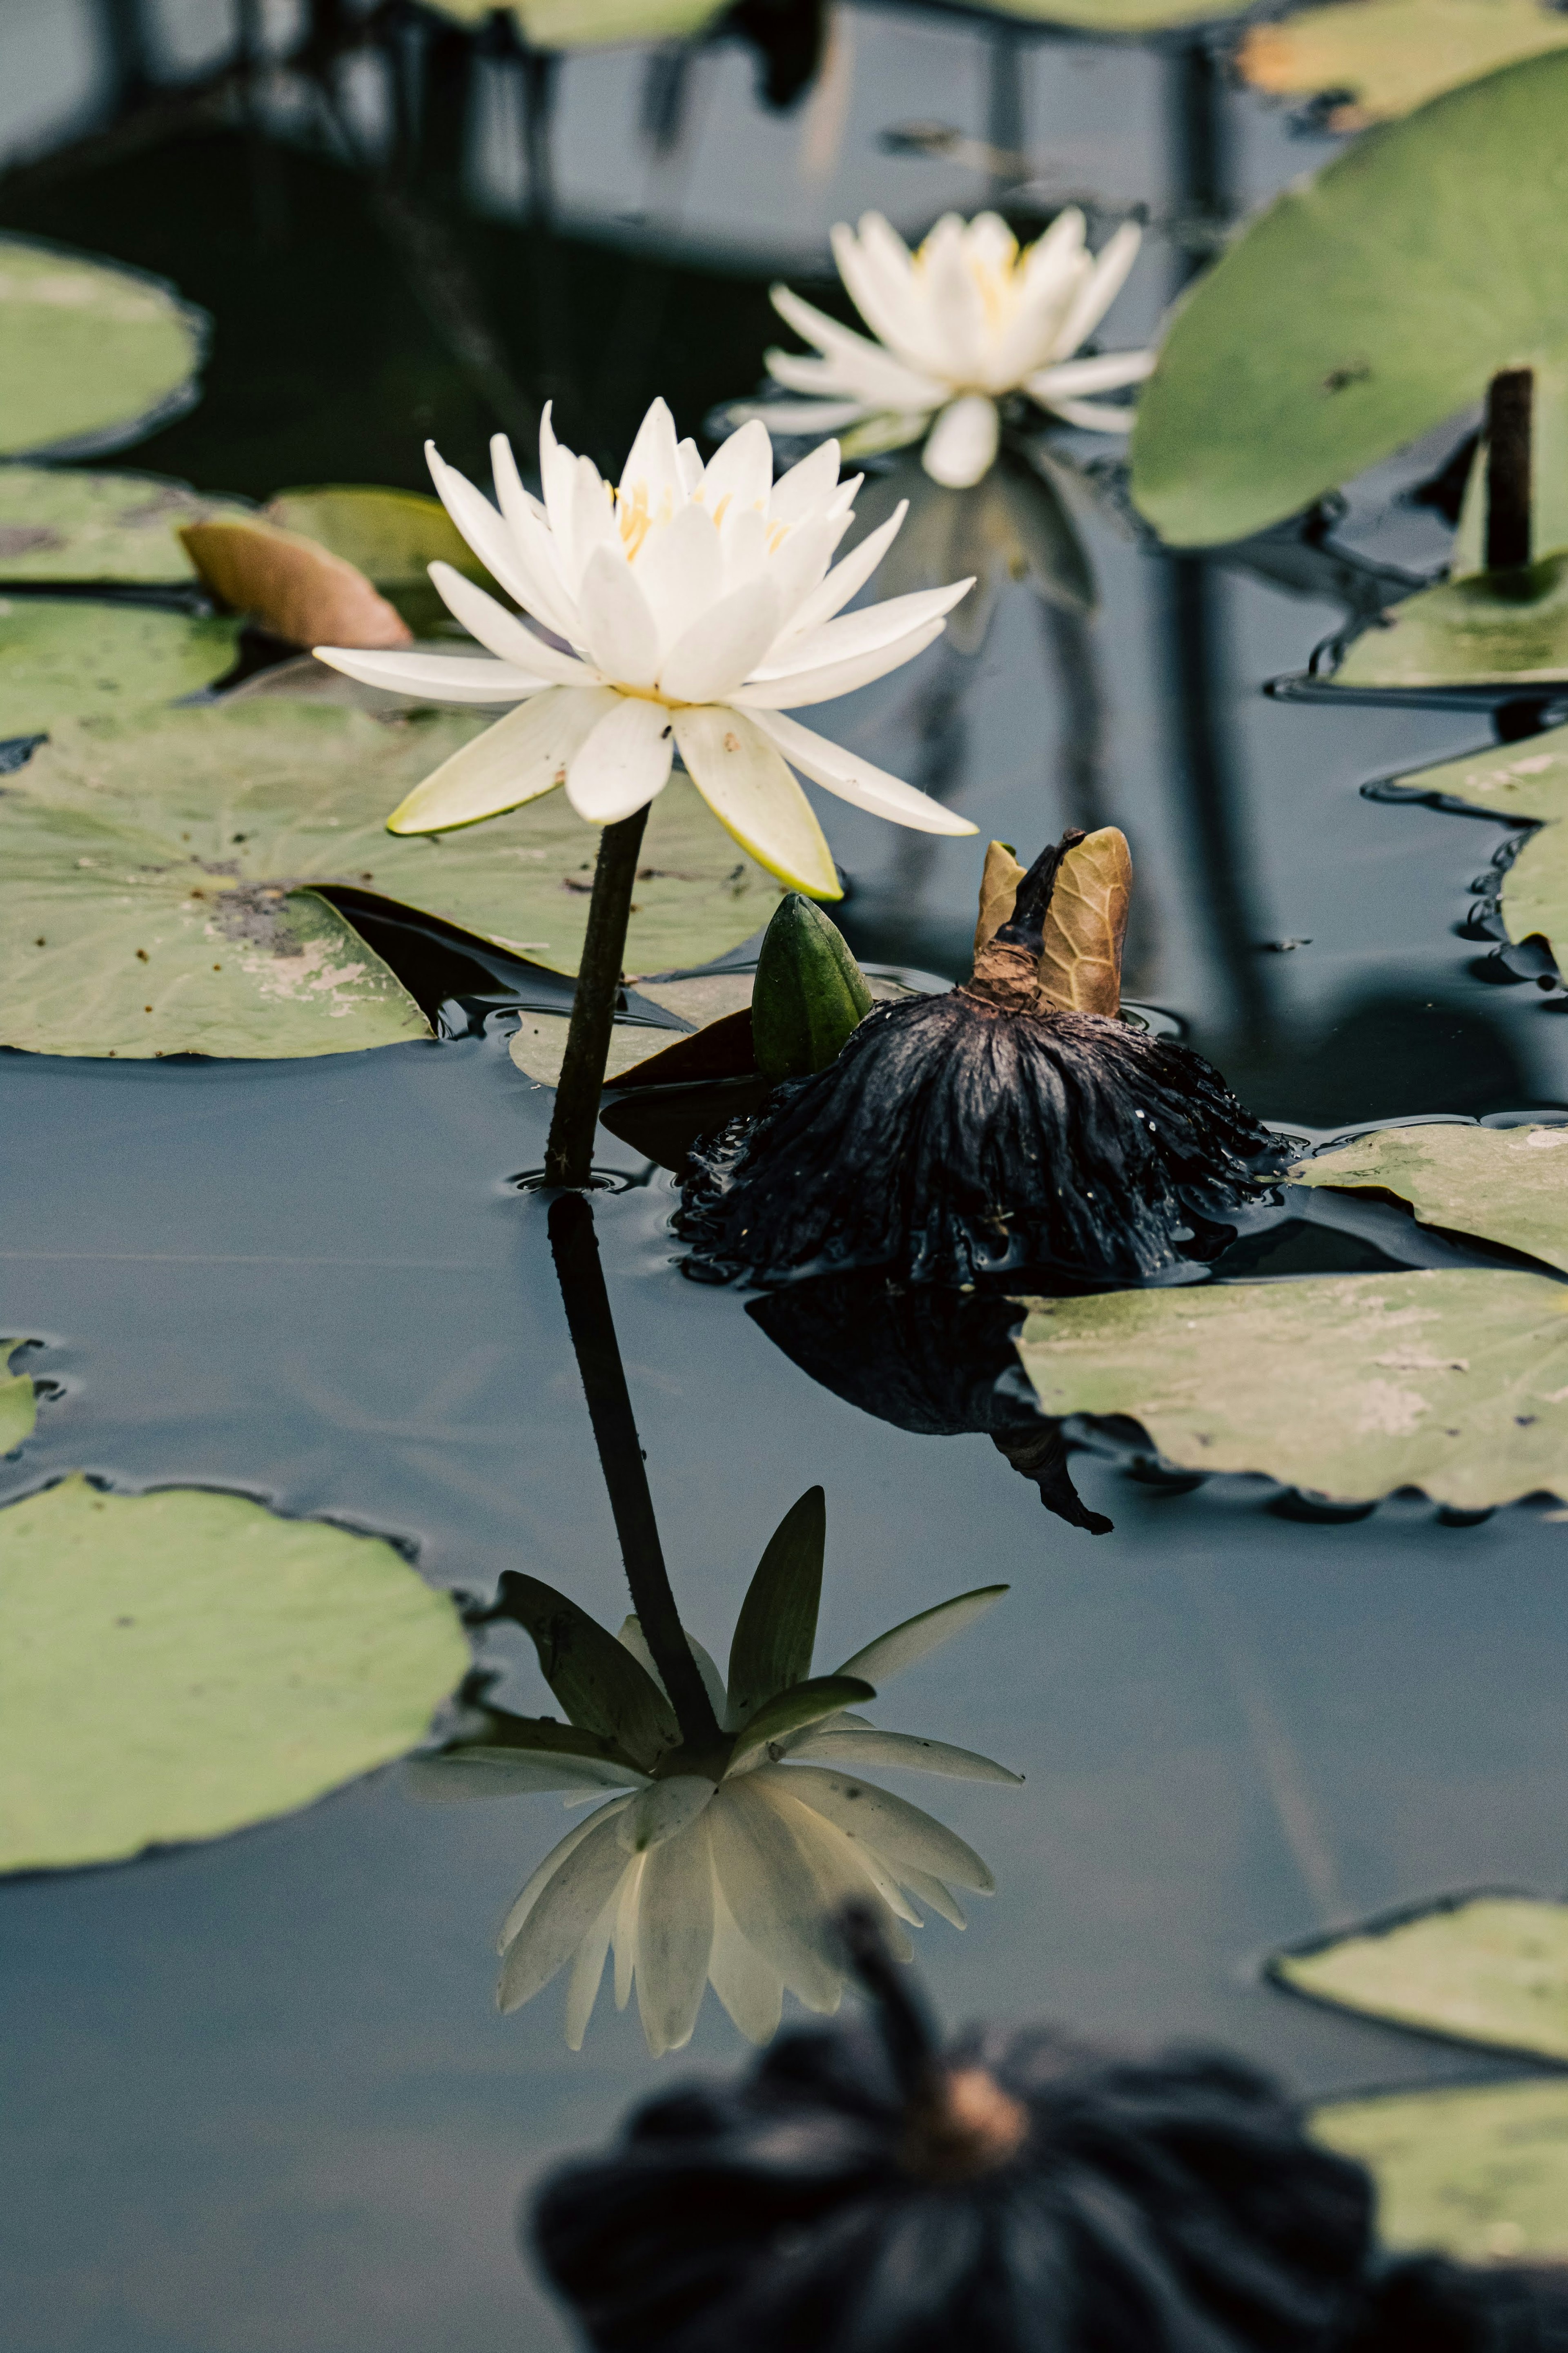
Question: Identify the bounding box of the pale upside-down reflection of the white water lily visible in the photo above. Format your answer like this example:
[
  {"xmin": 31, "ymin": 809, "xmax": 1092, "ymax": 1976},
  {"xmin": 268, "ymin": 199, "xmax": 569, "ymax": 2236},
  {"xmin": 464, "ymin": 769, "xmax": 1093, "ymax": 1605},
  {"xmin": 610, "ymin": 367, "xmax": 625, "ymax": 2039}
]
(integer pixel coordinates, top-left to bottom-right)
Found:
[{"xmin": 409, "ymin": 1558, "xmax": 1020, "ymax": 2056}]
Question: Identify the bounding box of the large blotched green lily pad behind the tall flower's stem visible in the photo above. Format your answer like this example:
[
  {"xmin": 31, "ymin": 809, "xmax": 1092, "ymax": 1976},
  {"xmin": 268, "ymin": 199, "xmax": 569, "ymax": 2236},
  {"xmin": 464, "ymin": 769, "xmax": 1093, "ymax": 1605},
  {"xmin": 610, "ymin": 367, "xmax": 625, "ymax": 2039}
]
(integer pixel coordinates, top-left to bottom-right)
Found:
[{"xmin": 0, "ymin": 701, "xmax": 776, "ymax": 1057}]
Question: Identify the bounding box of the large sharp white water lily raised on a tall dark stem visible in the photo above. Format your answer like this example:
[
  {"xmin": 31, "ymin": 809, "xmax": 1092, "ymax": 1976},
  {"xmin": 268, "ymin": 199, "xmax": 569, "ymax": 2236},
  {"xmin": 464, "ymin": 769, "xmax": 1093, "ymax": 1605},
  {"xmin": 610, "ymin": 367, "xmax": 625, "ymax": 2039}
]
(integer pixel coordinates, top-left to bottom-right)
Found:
[{"xmin": 315, "ymin": 400, "xmax": 976, "ymax": 899}]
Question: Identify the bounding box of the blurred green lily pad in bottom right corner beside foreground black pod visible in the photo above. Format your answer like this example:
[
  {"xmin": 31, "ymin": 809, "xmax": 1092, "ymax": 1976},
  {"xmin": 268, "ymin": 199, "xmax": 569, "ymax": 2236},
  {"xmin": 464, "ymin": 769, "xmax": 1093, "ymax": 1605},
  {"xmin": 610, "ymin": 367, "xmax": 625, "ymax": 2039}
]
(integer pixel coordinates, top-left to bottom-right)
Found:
[{"xmin": 1312, "ymin": 2078, "xmax": 1568, "ymax": 2264}]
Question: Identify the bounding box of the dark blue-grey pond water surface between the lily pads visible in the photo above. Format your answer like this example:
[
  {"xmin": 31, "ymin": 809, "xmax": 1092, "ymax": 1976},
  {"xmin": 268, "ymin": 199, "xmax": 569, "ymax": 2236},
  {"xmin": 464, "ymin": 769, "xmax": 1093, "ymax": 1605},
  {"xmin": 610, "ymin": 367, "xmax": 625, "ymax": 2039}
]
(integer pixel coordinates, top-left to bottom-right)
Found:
[{"xmin": 0, "ymin": 0, "xmax": 1568, "ymax": 2353}]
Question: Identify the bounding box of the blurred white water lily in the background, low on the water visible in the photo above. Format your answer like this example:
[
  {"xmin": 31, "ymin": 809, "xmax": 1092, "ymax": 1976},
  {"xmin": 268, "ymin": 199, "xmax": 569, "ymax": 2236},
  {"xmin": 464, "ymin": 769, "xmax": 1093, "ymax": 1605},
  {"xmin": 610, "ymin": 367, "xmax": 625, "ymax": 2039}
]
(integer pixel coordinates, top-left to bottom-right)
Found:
[{"xmin": 752, "ymin": 205, "xmax": 1154, "ymax": 489}]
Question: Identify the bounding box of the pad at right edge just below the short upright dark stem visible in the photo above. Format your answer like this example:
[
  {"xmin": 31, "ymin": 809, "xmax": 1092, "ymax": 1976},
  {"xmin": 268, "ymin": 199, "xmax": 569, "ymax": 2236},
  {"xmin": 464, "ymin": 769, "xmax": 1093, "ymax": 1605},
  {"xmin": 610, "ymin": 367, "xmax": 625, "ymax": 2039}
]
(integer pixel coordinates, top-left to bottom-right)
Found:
[{"xmin": 1333, "ymin": 553, "xmax": 1568, "ymax": 687}]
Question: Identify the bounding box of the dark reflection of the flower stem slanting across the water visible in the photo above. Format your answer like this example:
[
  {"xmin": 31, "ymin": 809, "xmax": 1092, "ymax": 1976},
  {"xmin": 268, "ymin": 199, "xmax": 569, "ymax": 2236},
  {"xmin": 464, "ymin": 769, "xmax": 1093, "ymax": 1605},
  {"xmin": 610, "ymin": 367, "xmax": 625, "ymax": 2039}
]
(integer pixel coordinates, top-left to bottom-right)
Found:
[{"xmin": 550, "ymin": 1193, "xmax": 724, "ymax": 1753}]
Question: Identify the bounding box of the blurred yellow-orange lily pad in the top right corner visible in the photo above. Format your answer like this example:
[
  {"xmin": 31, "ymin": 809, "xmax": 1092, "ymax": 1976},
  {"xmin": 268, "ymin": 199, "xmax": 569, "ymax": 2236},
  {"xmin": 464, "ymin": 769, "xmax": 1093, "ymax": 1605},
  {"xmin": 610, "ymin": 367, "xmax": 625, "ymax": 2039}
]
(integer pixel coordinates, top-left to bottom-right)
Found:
[{"xmin": 1239, "ymin": 0, "xmax": 1568, "ymax": 132}]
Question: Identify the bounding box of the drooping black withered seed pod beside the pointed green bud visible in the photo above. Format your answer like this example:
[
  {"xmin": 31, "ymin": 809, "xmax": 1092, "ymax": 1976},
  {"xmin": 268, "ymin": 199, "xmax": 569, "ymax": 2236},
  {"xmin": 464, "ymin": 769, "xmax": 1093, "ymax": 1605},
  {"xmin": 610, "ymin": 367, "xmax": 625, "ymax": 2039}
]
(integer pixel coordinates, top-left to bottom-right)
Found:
[{"xmin": 675, "ymin": 828, "xmax": 1291, "ymax": 1285}]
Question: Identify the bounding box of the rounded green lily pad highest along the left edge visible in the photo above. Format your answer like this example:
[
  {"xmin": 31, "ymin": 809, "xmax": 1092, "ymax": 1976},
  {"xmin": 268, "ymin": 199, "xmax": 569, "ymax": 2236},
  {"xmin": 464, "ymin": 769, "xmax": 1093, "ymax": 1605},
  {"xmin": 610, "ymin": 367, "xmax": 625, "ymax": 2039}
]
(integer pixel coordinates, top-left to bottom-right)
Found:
[{"xmin": 0, "ymin": 238, "xmax": 207, "ymax": 457}]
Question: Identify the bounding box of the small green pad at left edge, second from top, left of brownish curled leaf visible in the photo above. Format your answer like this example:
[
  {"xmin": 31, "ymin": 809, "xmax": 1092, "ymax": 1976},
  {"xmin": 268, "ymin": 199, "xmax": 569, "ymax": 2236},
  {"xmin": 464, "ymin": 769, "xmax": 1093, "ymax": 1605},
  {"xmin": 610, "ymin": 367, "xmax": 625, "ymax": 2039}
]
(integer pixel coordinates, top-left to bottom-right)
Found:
[{"xmin": 0, "ymin": 466, "xmax": 247, "ymax": 586}]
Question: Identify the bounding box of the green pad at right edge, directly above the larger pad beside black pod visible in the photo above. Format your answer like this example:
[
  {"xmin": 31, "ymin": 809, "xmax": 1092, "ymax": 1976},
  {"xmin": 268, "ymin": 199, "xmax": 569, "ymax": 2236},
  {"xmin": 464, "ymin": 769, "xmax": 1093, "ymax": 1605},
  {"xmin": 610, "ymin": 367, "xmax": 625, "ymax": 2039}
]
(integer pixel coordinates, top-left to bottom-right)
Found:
[{"xmin": 1291, "ymin": 1127, "xmax": 1568, "ymax": 1273}]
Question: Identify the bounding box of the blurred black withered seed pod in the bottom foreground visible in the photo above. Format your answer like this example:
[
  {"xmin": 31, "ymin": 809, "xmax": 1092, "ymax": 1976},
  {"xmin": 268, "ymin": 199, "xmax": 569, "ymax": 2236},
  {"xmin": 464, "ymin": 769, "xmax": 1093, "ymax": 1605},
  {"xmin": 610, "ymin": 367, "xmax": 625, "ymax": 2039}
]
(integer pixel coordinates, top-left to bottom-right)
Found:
[{"xmin": 534, "ymin": 1910, "xmax": 1568, "ymax": 2353}]
